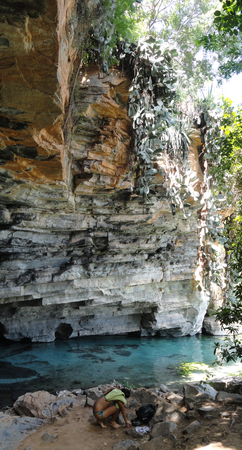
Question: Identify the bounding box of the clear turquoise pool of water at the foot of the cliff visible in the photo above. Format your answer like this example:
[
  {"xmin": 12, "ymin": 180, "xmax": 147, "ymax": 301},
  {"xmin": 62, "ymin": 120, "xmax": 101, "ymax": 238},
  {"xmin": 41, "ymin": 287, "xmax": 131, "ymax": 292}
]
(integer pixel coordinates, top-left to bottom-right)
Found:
[{"xmin": 0, "ymin": 335, "xmax": 242, "ymax": 404}]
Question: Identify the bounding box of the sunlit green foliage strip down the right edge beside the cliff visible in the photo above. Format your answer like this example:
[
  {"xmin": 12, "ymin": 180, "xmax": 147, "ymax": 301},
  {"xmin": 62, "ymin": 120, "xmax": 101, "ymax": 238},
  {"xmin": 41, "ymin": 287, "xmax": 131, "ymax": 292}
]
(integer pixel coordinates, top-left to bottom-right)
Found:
[{"xmin": 199, "ymin": 99, "xmax": 242, "ymax": 362}]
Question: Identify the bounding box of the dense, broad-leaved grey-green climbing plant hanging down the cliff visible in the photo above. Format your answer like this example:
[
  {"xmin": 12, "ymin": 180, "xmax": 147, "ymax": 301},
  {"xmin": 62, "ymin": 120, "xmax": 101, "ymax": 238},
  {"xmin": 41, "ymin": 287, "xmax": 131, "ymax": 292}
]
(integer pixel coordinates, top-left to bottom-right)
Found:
[{"xmin": 129, "ymin": 37, "xmax": 176, "ymax": 195}]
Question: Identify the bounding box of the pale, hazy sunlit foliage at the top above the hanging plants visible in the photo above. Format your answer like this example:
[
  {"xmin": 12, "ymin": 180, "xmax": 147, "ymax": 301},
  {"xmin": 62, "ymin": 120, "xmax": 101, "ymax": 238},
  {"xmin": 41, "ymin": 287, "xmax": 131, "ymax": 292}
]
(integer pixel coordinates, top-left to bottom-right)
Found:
[{"xmin": 139, "ymin": 0, "xmax": 219, "ymax": 100}]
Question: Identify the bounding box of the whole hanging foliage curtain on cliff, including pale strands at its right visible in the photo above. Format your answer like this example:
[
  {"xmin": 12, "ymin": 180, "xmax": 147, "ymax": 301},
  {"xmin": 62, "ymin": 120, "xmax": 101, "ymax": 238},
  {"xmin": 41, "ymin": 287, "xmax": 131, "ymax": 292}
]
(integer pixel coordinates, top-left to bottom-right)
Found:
[{"xmin": 123, "ymin": 36, "xmax": 198, "ymax": 213}]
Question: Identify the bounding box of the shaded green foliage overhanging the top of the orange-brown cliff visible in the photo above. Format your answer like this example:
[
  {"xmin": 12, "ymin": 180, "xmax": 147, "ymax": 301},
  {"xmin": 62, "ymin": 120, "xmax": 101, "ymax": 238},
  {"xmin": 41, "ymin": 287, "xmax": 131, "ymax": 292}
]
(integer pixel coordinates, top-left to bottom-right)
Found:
[{"xmin": 75, "ymin": 0, "xmax": 142, "ymax": 72}]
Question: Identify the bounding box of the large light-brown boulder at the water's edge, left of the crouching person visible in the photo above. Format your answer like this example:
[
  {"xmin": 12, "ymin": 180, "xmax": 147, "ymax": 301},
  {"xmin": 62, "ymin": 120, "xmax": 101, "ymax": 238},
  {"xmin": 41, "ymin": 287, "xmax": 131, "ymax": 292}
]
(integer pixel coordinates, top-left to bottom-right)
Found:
[{"xmin": 13, "ymin": 391, "xmax": 57, "ymax": 418}]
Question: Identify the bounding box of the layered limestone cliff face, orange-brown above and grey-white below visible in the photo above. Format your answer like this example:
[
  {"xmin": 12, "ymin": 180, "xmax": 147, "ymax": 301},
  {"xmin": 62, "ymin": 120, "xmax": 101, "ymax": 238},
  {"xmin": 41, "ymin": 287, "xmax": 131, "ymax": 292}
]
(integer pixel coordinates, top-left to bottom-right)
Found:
[{"xmin": 0, "ymin": 0, "xmax": 207, "ymax": 341}]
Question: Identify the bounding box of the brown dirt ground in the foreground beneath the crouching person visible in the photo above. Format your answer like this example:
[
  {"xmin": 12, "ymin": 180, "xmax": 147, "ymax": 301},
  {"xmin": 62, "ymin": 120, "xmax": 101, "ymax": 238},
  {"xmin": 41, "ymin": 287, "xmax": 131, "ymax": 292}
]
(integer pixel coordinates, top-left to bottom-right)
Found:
[{"xmin": 18, "ymin": 403, "xmax": 242, "ymax": 450}]
